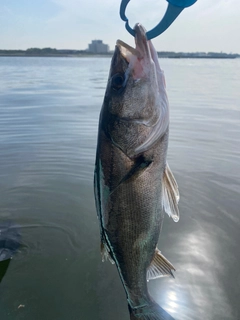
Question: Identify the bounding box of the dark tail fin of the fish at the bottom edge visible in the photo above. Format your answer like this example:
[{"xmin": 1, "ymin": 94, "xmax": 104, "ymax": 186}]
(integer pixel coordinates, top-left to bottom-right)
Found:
[{"xmin": 128, "ymin": 302, "xmax": 174, "ymax": 320}]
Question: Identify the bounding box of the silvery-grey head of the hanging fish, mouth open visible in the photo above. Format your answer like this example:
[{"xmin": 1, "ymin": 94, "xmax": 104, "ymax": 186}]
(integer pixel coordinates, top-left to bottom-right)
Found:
[{"xmin": 104, "ymin": 24, "xmax": 169, "ymax": 155}]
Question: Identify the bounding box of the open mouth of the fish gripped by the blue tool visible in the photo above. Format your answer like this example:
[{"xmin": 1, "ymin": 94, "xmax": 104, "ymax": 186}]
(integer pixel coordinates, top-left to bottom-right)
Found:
[{"xmin": 116, "ymin": 23, "xmax": 151, "ymax": 62}]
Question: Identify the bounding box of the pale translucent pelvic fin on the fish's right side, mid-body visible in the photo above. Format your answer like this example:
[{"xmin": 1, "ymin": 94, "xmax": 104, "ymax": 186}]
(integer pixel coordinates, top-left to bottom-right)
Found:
[{"xmin": 162, "ymin": 164, "xmax": 180, "ymax": 222}]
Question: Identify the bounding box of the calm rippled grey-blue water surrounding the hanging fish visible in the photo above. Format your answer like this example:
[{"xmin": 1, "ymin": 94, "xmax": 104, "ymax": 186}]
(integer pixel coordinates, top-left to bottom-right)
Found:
[{"xmin": 0, "ymin": 57, "xmax": 240, "ymax": 320}]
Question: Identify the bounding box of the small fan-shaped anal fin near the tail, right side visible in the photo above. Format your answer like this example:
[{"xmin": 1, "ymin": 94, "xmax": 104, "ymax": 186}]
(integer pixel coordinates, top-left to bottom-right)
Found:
[{"xmin": 147, "ymin": 248, "xmax": 175, "ymax": 280}]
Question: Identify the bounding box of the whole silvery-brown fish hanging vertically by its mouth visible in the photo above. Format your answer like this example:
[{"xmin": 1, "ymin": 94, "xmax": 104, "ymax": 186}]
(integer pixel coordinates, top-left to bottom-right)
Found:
[{"xmin": 94, "ymin": 23, "xmax": 179, "ymax": 320}]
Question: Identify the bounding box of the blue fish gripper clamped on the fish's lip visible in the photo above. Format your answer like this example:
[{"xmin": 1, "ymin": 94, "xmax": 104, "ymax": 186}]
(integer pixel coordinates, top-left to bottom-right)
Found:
[{"xmin": 120, "ymin": 0, "xmax": 197, "ymax": 40}]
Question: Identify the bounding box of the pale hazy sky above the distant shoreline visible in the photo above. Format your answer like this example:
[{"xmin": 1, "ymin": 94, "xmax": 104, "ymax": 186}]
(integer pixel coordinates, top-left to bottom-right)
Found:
[{"xmin": 0, "ymin": 0, "xmax": 240, "ymax": 53}]
